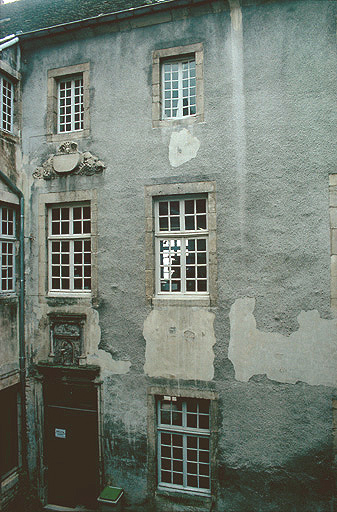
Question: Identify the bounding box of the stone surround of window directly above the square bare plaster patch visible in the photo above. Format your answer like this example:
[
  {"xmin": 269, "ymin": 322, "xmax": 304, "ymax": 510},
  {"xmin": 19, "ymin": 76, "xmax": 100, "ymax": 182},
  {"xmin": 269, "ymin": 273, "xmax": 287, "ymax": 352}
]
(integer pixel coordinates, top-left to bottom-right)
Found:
[{"xmin": 145, "ymin": 181, "xmax": 217, "ymax": 306}]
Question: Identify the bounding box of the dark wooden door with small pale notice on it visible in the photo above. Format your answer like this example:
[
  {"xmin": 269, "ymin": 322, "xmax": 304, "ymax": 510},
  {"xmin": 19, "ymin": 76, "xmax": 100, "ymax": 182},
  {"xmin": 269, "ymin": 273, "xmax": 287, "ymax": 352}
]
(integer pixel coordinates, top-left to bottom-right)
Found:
[{"xmin": 45, "ymin": 384, "xmax": 99, "ymax": 507}]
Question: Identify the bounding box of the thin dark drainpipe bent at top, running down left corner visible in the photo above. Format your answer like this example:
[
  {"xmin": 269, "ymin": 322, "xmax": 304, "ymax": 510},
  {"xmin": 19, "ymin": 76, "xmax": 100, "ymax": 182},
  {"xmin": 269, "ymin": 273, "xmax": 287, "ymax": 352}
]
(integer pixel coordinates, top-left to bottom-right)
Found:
[{"xmin": 0, "ymin": 170, "xmax": 28, "ymax": 475}]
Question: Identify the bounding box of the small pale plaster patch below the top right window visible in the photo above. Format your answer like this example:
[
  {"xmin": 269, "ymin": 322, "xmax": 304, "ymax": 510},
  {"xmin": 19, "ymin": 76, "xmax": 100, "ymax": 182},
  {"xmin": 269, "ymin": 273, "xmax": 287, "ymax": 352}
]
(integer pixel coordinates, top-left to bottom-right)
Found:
[{"xmin": 169, "ymin": 128, "xmax": 200, "ymax": 167}]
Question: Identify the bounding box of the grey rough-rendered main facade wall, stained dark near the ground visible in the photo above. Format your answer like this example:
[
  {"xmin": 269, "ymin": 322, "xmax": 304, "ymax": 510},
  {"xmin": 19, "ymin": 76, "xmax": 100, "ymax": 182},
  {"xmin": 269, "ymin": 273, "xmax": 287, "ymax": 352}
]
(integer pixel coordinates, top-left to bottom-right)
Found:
[{"xmin": 23, "ymin": 1, "xmax": 337, "ymax": 512}]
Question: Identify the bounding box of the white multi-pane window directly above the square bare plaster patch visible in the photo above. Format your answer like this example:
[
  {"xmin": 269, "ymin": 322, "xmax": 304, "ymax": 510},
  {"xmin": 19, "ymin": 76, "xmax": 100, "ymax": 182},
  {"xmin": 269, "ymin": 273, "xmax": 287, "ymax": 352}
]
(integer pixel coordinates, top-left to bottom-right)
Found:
[{"xmin": 155, "ymin": 196, "xmax": 208, "ymax": 295}]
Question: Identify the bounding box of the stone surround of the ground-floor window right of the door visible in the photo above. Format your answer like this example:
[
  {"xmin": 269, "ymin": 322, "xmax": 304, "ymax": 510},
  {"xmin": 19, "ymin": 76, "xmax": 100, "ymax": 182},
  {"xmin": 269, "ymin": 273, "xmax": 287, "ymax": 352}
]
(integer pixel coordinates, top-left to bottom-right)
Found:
[{"xmin": 147, "ymin": 384, "xmax": 218, "ymax": 512}]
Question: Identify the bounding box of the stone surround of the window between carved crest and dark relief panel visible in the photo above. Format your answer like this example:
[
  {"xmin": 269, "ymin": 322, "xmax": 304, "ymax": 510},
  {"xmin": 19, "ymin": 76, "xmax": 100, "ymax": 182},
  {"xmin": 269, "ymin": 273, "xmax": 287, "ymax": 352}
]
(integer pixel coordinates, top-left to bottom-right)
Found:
[{"xmin": 38, "ymin": 189, "xmax": 98, "ymax": 302}]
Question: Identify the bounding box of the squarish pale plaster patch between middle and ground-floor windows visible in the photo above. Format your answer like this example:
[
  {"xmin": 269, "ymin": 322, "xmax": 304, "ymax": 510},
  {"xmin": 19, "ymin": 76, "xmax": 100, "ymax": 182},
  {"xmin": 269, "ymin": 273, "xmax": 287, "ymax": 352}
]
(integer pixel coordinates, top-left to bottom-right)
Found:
[{"xmin": 143, "ymin": 306, "xmax": 215, "ymax": 381}]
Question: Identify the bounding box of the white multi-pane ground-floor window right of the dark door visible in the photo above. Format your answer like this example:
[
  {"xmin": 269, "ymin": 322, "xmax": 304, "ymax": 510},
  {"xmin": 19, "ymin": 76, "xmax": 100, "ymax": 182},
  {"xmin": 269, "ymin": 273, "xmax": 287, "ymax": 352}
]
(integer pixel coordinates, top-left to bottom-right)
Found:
[{"xmin": 157, "ymin": 396, "xmax": 210, "ymax": 494}]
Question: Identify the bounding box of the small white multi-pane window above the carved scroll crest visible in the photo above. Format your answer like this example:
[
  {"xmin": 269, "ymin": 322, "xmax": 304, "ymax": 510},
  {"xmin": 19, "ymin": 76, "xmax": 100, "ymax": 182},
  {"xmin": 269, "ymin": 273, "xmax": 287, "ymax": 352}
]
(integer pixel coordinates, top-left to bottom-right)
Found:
[{"xmin": 58, "ymin": 76, "xmax": 84, "ymax": 133}]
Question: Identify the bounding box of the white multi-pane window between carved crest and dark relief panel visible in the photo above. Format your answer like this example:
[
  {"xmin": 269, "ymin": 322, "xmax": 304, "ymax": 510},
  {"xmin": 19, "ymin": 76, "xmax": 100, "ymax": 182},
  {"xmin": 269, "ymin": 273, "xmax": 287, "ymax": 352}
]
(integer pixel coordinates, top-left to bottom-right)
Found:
[{"xmin": 48, "ymin": 204, "xmax": 91, "ymax": 292}]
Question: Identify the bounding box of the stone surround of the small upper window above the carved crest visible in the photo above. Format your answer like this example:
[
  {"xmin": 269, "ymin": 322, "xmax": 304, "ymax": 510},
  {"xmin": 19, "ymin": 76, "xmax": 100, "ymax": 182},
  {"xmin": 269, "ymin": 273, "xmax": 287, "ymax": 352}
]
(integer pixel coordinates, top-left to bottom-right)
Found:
[{"xmin": 47, "ymin": 62, "xmax": 90, "ymax": 142}]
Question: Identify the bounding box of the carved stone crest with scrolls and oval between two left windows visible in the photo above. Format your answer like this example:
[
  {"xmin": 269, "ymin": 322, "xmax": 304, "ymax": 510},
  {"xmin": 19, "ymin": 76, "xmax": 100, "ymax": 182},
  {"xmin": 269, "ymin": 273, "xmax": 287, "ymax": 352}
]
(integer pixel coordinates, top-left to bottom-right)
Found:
[{"xmin": 33, "ymin": 141, "xmax": 105, "ymax": 180}]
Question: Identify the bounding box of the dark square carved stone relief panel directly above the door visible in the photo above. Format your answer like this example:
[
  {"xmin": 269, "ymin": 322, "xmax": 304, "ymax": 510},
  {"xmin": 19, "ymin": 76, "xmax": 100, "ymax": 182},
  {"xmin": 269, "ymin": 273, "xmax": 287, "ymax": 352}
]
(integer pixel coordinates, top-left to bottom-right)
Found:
[{"xmin": 49, "ymin": 313, "xmax": 85, "ymax": 366}]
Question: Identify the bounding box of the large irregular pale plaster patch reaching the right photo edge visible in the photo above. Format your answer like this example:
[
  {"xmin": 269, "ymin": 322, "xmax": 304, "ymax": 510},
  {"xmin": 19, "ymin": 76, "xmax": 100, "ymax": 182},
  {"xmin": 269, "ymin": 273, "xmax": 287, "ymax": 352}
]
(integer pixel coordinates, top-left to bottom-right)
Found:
[{"xmin": 228, "ymin": 297, "xmax": 337, "ymax": 386}]
